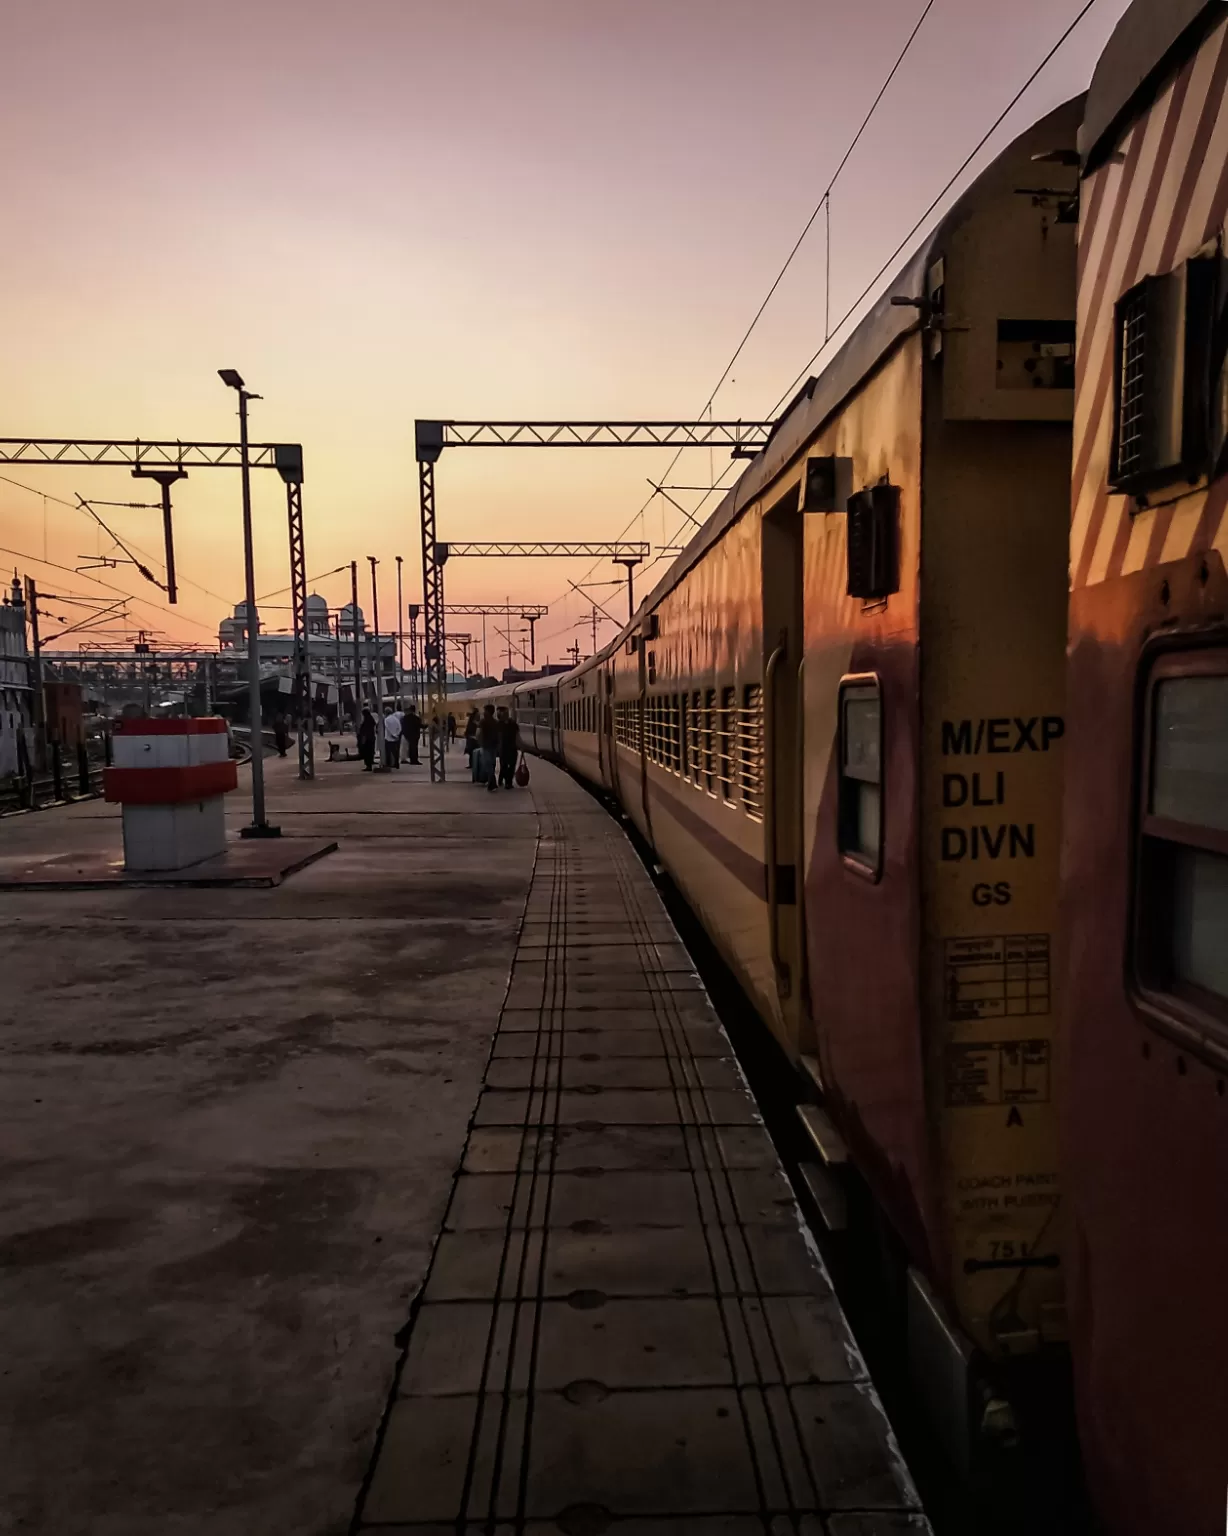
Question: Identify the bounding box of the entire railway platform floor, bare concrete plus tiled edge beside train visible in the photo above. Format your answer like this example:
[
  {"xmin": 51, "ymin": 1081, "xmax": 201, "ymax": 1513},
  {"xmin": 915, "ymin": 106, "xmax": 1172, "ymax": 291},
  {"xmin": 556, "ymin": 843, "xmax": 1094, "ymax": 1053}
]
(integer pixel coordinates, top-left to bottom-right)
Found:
[{"xmin": 0, "ymin": 737, "xmax": 928, "ymax": 1536}]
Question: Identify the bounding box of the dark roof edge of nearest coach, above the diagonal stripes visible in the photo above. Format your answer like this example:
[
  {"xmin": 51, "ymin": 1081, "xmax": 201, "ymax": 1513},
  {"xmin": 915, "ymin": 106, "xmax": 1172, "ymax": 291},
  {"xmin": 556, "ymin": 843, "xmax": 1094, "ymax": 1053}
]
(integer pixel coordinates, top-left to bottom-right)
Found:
[{"xmin": 1079, "ymin": 0, "xmax": 1228, "ymax": 174}]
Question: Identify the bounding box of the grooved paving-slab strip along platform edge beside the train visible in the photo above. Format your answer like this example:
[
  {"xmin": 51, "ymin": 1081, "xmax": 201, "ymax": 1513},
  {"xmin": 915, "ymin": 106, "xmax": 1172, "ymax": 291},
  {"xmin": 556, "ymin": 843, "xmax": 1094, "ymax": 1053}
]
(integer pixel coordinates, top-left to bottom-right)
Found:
[{"xmin": 357, "ymin": 763, "xmax": 928, "ymax": 1536}]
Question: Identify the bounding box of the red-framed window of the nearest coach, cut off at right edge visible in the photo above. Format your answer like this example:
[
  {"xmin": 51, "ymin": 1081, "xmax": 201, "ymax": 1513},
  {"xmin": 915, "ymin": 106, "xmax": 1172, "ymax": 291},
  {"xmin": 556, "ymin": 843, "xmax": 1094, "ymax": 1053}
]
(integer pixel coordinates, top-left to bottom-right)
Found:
[{"xmin": 1134, "ymin": 650, "xmax": 1228, "ymax": 1043}]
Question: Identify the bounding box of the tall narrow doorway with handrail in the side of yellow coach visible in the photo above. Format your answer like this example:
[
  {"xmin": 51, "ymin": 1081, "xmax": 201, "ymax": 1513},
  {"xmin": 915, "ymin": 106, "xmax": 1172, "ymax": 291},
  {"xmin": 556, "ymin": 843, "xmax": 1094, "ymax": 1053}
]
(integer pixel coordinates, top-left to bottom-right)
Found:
[{"xmin": 761, "ymin": 485, "xmax": 815, "ymax": 1055}]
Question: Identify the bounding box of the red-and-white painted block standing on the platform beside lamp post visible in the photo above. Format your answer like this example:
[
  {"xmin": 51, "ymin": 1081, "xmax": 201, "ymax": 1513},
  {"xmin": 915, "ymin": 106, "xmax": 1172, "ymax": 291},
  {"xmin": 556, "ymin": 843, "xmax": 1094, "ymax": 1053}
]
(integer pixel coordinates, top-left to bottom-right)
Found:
[{"xmin": 103, "ymin": 716, "xmax": 238, "ymax": 872}]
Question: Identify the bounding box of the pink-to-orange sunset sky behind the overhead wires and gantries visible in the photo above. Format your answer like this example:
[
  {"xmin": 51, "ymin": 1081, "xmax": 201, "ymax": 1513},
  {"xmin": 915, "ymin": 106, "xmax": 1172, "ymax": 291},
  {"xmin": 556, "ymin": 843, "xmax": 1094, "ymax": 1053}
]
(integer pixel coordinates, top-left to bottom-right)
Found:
[{"xmin": 0, "ymin": 0, "xmax": 1127, "ymax": 668}]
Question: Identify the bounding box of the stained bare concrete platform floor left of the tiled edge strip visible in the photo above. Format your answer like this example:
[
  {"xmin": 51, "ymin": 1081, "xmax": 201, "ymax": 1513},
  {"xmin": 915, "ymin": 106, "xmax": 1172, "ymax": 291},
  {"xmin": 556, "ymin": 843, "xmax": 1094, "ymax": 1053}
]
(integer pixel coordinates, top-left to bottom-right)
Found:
[{"xmin": 0, "ymin": 737, "xmax": 538, "ymax": 1536}]
